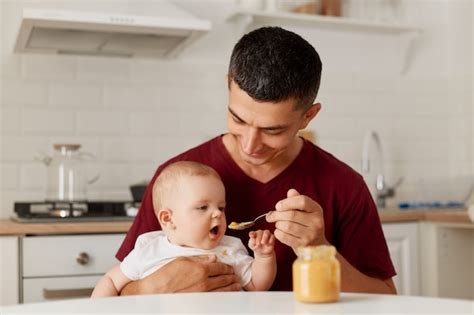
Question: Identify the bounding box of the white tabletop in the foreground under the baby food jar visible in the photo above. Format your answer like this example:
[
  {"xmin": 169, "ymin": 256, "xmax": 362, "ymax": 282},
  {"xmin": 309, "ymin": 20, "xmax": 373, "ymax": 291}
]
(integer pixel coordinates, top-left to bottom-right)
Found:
[{"xmin": 0, "ymin": 292, "xmax": 474, "ymax": 315}]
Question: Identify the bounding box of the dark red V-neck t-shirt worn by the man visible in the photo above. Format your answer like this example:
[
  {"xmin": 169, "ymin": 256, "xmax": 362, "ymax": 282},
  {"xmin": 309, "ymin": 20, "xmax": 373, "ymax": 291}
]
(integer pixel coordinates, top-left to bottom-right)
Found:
[{"xmin": 116, "ymin": 136, "xmax": 396, "ymax": 291}]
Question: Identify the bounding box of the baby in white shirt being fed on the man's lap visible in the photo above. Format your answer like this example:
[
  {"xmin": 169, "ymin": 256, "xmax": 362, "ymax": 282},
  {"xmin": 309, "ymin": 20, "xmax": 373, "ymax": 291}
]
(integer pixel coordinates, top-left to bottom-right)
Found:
[{"xmin": 92, "ymin": 161, "xmax": 277, "ymax": 297}]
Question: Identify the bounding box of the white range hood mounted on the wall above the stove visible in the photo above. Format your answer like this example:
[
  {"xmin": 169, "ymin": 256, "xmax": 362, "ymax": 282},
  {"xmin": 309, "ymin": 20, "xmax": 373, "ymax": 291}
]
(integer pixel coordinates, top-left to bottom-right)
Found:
[{"xmin": 15, "ymin": 2, "xmax": 211, "ymax": 57}]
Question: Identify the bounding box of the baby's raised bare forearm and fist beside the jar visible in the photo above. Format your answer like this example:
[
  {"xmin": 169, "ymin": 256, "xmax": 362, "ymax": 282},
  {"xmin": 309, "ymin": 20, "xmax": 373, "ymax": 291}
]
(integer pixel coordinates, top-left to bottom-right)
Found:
[{"xmin": 244, "ymin": 230, "xmax": 277, "ymax": 291}]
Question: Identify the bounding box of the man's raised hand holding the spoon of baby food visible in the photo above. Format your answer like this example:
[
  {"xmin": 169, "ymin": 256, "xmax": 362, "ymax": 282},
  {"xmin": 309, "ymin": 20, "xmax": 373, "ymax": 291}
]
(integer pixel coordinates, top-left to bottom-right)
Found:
[{"xmin": 266, "ymin": 189, "xmax": 329, "ymax": 251}]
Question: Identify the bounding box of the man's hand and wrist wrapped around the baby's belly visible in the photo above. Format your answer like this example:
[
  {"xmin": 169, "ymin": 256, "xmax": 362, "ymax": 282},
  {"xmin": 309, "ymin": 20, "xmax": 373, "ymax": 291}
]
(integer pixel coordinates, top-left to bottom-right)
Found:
[{"xmin": 120, "ymin": 255, "xmax": 240, "ymax": 295}]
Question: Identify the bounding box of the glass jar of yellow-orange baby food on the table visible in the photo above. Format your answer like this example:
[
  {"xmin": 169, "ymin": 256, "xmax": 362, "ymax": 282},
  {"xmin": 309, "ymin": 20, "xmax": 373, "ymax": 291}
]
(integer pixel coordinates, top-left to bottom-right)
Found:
[{"xmin": 293, "ymin": 245, "xmax": 341, "ymax": 303}]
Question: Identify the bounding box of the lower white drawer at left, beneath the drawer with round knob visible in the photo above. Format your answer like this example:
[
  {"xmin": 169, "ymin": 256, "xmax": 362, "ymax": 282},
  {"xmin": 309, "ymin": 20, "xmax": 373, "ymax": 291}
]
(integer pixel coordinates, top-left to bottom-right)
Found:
[{"xmin": 23, "ymin": 276, "xmax": 101, "ymax": 303}]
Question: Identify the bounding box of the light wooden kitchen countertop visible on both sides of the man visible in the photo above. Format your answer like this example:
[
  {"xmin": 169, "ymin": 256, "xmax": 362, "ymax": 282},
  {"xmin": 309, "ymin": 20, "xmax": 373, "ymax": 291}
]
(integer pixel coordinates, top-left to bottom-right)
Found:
[{"xmin": 0, "ymin": 209, "xmax": 474, "ymax": 235}]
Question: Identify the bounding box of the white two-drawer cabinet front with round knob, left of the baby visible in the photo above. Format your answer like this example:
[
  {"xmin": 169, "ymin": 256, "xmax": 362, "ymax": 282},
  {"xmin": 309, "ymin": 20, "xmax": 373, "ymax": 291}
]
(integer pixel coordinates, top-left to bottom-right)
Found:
[{"xmin": 20, "ymin": 234, "xmax": 125, "ymax": 303}]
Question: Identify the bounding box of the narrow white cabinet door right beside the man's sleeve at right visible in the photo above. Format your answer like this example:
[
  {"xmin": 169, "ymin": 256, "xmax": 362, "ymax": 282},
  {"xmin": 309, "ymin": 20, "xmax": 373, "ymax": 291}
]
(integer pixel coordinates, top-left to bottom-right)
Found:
[{"xmin": 382, "ymin": 223, "xmax": 420, "ymax": 295}]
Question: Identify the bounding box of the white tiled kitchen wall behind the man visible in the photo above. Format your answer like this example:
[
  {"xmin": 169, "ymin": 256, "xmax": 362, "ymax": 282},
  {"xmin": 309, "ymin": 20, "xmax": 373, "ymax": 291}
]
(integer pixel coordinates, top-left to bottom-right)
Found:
[{"xmin": 0, "ymin": 0, "xmax": 474, "ymax": 218}]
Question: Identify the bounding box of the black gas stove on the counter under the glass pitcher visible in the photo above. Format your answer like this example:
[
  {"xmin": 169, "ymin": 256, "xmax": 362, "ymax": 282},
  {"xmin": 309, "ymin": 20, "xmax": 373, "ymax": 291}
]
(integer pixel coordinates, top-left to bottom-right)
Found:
[{"xmin": 12, "ymin": 201, "xmax": 140, "ymax": 223}]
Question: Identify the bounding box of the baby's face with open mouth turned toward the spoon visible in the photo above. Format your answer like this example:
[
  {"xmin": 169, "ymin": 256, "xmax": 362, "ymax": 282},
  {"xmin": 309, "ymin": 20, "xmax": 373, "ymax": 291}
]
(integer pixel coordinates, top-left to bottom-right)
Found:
[{"xmin": 169, "ymin": 176, "xmax": 227, "ymax": 249}]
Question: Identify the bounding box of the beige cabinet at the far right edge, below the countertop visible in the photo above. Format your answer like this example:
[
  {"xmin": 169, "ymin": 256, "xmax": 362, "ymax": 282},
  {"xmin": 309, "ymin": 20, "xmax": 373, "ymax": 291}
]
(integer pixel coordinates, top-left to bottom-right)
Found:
[{"xmin": 420, "ymin": 222, "xmax": 474, "ymax": 300}]
